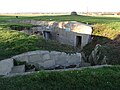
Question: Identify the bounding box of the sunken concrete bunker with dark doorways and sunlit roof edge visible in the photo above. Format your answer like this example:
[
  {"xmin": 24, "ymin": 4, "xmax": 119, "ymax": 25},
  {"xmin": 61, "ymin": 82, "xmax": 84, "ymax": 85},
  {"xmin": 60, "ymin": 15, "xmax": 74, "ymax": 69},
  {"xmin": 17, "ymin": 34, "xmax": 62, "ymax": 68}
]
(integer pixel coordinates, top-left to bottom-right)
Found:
[{"xmin": 9, "ymin": 20, "xmax": 92, "ymax": 48}]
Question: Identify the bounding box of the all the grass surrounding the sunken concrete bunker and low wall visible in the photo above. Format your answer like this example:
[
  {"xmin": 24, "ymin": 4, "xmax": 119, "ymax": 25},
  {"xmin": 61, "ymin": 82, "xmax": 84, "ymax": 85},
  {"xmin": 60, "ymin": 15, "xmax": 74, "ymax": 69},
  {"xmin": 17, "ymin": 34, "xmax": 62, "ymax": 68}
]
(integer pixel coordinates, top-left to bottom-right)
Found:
[{"xmin": 0, "ymin": 15, "xmax": 120, "ymax": 90}]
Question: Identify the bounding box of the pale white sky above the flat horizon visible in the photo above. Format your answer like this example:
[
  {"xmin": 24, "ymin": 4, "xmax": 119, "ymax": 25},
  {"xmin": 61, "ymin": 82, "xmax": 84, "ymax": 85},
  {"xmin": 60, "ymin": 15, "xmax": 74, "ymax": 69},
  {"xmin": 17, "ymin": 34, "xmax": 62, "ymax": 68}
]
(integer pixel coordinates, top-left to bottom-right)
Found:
[{"xmin": 0, "ymin": 0, "xmax": 120, "ymax": 13}]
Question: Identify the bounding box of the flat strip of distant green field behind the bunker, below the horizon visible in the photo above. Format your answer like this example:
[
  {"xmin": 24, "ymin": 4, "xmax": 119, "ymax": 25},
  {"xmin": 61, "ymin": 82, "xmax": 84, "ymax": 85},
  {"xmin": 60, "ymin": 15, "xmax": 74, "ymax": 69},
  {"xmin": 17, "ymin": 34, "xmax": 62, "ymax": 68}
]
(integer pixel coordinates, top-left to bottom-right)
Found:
[{"xmin": 0, "ymin": 15, "xmax": 120, "ymax": 30}]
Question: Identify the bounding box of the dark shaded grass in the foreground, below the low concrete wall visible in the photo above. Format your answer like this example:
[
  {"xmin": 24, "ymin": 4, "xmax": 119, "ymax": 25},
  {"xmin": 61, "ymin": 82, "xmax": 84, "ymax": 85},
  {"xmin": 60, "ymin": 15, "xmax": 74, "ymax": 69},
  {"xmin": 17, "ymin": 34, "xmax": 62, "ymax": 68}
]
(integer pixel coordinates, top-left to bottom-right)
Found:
[{"xmin": 0, "ymin": 66, "xmax": 120, "ymax": 90}]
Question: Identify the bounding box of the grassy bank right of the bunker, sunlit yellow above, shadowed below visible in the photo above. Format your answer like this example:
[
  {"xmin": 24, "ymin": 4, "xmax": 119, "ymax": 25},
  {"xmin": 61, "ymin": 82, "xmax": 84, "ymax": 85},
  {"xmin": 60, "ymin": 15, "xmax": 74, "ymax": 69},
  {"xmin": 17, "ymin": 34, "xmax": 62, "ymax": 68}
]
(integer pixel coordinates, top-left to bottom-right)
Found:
[{"xmin": 83, "ymin": 24, "xmax": 120, "ymax": 64}]
